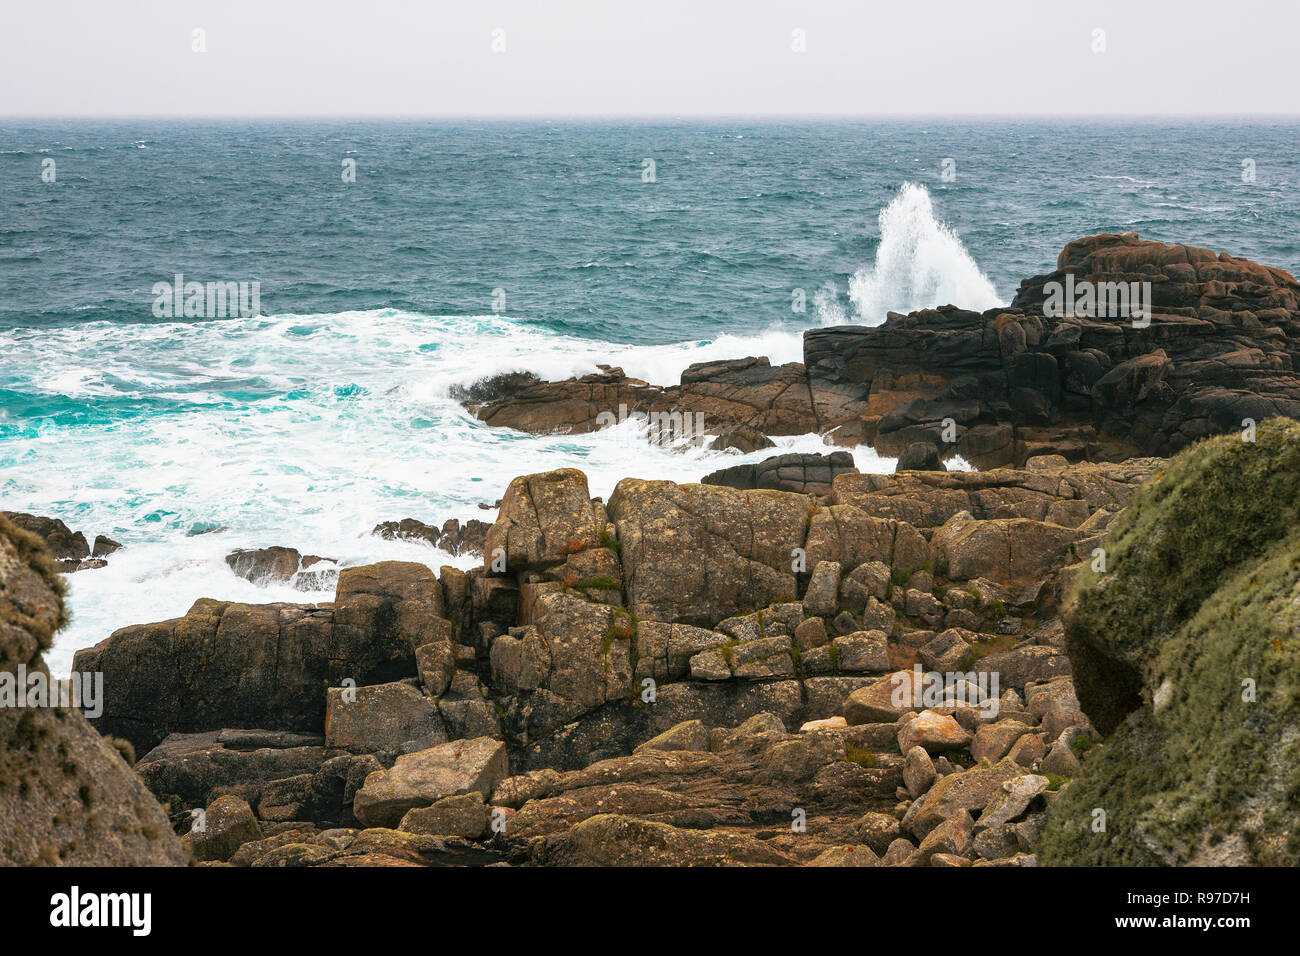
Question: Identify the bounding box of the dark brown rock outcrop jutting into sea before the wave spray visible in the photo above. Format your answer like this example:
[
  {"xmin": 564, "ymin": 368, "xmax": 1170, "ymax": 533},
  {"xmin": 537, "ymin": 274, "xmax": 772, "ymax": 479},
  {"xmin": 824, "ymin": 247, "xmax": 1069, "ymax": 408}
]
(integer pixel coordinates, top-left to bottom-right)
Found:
[{"xmin": 465, "ymin": 233, "xmax": 1300, "ymax": 468}]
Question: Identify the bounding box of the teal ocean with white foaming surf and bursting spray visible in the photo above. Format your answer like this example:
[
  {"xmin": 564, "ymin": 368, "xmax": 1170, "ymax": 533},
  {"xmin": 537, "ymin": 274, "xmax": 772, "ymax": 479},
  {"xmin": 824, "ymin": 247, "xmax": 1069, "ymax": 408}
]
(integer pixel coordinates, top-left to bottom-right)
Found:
[{"xmin": 0, "ymin": 120, "xmax": 1300, "ymax": 672}]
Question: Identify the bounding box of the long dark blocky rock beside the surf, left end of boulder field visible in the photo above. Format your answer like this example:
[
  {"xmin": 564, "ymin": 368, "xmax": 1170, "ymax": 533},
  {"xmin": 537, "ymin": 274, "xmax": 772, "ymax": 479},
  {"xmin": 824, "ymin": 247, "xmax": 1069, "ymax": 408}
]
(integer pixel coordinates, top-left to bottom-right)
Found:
[{"xmin": 73, "ymin": 562, "xmax": 421, "ymax": 753}]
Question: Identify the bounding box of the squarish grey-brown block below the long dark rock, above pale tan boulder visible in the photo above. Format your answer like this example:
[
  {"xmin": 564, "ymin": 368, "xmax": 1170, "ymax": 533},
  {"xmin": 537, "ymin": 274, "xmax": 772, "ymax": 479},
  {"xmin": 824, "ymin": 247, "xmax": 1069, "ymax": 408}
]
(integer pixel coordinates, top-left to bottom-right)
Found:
[{"xmin": 325, "ymin": 682, "xmax": 447, "ymax": 753}]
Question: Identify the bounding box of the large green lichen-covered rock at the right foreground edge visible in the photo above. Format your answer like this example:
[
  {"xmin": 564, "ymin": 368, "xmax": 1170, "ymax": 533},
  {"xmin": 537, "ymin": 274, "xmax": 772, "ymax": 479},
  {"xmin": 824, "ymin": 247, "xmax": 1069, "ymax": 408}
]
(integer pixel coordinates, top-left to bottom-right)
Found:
[{"xmin": 1040, "ymin": 419, "xmax": 1300, "ymax": 866}]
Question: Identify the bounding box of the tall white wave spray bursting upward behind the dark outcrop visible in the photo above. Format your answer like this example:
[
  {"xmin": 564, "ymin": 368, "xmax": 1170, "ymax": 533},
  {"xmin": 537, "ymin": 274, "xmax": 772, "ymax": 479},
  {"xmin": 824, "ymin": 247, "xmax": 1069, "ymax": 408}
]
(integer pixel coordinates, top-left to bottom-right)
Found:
[{"xmin": 814, "ymin": 182, "xmax": 1006, "ymax": 325}]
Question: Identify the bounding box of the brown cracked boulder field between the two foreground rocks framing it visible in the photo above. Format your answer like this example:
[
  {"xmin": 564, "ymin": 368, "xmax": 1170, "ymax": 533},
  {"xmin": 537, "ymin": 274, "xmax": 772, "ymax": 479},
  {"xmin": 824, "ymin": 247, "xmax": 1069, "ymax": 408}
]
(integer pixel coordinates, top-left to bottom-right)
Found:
[{"xmin": 32, "ymin": 457, "xmax": 1161, "ymax": 866}]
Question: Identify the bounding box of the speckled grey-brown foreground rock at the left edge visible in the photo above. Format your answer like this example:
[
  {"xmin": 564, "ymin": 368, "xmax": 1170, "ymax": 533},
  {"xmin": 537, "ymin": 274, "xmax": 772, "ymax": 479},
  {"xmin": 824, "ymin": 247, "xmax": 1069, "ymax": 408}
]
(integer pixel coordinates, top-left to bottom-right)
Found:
[{"xmin": 0, "ymin": 516, "xmax": 189, "ymax": 866}]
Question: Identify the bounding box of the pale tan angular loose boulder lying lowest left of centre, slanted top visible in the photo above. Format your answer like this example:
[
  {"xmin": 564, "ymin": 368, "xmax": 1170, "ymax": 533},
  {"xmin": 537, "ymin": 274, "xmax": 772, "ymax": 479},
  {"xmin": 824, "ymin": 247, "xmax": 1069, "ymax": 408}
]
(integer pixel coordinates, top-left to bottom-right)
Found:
[{"xmin": 352, "ymin": 737, "xmax": 508, "ymax": 826}]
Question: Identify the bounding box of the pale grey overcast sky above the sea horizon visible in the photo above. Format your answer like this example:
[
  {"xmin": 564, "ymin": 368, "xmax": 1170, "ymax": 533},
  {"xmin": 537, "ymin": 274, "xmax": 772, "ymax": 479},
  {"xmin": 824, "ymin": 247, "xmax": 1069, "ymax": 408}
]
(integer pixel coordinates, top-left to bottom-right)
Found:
[{"xmin": 0, "ymin": 0, "xmax": 1300, "ymax": 117}]
